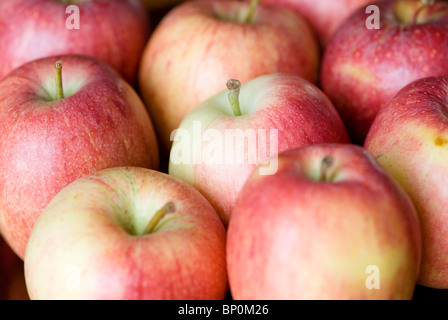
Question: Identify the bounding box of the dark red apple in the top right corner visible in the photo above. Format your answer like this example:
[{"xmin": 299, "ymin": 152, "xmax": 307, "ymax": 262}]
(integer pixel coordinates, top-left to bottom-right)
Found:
[{"xmin": 321, "ymin": 0, "xmax": 448, "ymax": 145}]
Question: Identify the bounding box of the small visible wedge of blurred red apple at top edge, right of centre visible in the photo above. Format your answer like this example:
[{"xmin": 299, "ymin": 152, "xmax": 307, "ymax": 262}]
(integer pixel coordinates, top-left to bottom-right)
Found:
[{"xmin": 246, "ymin": 0, "xmax": 380, "ymax": 48}]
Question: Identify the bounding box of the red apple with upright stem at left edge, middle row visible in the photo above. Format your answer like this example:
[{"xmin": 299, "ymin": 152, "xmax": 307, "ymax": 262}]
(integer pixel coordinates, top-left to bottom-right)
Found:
[{"xmin": 0, "ymin": 55, "xmax": 159, "ymax": 259}]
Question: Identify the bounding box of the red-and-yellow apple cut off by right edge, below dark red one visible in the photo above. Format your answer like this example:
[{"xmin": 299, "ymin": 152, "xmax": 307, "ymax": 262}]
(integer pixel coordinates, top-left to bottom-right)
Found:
[{"xmin": 365, "ymin": 76, "xmax": 448, "ymax": 289}]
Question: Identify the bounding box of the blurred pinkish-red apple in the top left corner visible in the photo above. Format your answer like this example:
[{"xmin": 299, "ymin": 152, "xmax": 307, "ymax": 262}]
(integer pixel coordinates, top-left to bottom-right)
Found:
[{"xmin": 0, "ymin": 0, "xmax": 150, "ymax": 84}]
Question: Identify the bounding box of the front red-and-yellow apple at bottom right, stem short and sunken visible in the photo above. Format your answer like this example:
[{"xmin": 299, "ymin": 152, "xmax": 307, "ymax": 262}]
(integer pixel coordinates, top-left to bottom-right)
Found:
[{"xmin": 227, "ymin": 144, "xmax": 422, "ymax": 300}]
